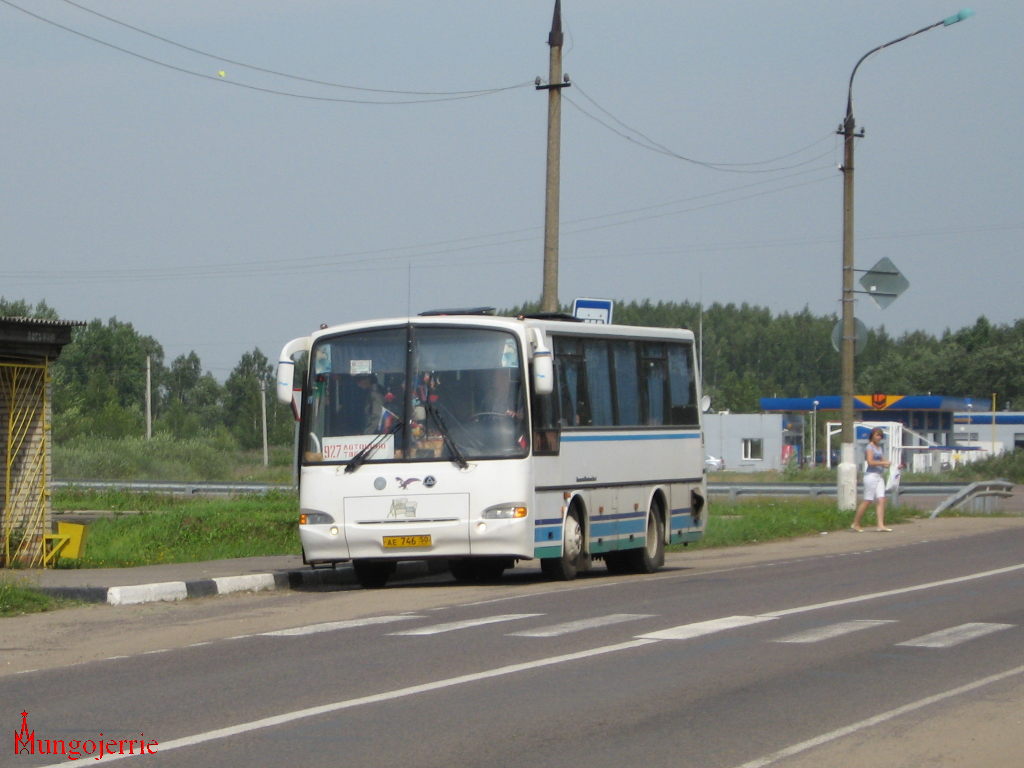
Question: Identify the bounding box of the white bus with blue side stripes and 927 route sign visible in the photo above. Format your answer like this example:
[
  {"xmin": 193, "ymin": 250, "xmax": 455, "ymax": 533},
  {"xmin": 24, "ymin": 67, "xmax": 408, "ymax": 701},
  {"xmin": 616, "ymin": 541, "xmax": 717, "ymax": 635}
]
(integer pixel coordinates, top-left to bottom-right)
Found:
[{"xmin": 276, "ymin": 310, "xmax": 708, "ymax": 587}]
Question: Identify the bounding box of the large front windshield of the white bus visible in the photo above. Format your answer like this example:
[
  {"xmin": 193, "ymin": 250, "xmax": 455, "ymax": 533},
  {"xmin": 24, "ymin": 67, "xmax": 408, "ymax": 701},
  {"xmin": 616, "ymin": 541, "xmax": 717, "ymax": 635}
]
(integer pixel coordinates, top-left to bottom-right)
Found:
[{"xmin": 303, "ymin": 326, "xmax": 528, "ymax": 465}]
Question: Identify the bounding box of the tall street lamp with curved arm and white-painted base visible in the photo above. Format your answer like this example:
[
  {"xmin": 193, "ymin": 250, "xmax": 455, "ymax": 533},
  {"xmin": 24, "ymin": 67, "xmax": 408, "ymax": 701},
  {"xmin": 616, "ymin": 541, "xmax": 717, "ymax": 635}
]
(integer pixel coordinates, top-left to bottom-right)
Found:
[{"xmin": 836, "ymin": 8, "xmax": 974, "ymax": 510}]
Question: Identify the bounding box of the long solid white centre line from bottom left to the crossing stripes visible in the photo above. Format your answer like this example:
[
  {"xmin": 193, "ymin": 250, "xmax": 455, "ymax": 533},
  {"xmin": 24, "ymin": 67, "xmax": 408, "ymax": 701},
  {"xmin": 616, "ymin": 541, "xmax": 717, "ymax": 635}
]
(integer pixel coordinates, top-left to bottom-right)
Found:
[{"xmin": 32, "ymin": 638, "xmax": 655, "ymax": 768}]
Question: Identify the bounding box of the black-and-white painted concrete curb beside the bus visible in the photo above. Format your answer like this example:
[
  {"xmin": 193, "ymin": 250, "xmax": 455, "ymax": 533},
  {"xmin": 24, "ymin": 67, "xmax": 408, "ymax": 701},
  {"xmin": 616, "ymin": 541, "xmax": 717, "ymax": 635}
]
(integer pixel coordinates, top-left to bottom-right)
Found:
[{"xmin": 35, "ymin": 560, "xmax": 447, "ymax": 605}]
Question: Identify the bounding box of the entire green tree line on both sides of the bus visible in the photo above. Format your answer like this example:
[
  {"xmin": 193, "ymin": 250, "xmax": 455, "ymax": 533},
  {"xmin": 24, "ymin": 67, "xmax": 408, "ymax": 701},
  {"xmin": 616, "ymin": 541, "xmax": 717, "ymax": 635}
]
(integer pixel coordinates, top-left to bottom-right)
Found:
[{"xmin": 0, "ymin": 297, "xmax": 1024, "ymax": 450}]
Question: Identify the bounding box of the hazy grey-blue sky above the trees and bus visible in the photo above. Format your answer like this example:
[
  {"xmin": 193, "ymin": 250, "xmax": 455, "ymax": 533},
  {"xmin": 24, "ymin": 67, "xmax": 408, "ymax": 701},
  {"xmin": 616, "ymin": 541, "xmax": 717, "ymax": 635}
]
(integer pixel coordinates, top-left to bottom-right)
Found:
[{"xmin": 0, "ymin": 0, "xmax": 1024, "ymax": 380}]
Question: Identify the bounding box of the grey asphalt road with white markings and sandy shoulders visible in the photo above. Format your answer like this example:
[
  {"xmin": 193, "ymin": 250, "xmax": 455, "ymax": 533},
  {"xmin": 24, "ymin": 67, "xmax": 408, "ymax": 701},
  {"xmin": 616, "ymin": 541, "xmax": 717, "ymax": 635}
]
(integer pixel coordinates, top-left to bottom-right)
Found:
[{"xmin": 0, "ymin": 519, "xmax": 1024, "ymax": 768}]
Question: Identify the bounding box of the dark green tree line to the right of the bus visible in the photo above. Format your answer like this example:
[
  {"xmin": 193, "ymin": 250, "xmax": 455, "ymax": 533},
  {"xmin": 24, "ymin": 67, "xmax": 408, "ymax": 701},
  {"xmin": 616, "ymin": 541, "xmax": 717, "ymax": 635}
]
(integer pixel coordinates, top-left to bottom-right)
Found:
[{"xmin": 509, "ymin": 301, "xmax": 1024, "ymax": 413}]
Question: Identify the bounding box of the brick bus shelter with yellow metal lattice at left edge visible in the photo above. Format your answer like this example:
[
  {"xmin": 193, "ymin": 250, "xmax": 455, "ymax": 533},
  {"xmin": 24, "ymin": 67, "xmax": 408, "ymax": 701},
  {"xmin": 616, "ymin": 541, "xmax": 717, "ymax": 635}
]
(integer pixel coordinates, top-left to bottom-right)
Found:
[{"xmin": 0, "ymin": 317, "xmax": 84, "ymax": 567}]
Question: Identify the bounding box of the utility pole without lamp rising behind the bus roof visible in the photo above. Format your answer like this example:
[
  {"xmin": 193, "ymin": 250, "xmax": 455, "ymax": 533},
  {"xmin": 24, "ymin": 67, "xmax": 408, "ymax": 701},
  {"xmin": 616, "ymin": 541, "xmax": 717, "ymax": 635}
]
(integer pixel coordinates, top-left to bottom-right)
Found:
[{"xmin": 536, "ymin": 0, "xmax": 569, "ymax": 312}]
